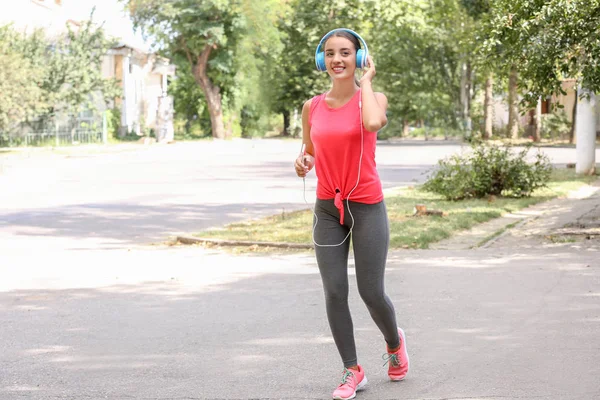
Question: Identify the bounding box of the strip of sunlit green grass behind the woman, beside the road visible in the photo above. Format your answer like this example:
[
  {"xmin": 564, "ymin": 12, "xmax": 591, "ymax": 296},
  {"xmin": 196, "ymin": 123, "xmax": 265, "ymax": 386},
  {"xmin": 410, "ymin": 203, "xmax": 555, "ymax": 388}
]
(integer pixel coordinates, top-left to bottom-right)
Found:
[{"xmin": 195, "ymin": 169, "xmax": 598, "ymax": 249}]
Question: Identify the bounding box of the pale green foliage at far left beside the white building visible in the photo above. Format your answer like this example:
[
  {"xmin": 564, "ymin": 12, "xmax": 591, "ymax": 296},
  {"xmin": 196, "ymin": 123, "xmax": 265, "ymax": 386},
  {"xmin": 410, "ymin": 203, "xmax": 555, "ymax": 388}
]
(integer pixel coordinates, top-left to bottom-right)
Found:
[{"xmin": 0, "ymin": 19, "xmax": 119, "ymax": 130}]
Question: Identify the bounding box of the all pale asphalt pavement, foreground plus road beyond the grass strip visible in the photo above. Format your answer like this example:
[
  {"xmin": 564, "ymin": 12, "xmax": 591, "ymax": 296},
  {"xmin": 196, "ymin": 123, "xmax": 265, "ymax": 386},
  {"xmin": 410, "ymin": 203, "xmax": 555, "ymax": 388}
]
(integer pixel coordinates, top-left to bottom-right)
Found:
[{"xmin": 0, "ymin": 142, "xmax": 600, "ymax": 399}]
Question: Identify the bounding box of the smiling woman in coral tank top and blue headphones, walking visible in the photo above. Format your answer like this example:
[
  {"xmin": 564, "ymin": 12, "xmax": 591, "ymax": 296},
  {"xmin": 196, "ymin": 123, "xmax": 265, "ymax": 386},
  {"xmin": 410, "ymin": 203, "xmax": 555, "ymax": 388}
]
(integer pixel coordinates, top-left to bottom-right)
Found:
[{"xmin": 295, "ymin": 29, "xmax": 409, "ymax": 400}]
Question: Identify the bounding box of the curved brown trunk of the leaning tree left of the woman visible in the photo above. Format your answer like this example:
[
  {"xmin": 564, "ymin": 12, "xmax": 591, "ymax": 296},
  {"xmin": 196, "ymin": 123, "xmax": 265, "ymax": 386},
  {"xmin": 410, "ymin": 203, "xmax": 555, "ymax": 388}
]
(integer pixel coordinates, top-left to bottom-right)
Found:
[{"xmin": 192, "ymin": 45, "xmax": 225, "ymax": 139}]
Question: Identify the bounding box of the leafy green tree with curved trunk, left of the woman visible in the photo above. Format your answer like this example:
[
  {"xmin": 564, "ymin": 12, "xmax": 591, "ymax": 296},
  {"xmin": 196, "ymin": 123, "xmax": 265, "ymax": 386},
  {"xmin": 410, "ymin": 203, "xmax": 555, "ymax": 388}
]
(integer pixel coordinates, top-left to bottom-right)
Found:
[{"xmin": 123, "ymin": 0, "xmax": 286, "ymax": 136}]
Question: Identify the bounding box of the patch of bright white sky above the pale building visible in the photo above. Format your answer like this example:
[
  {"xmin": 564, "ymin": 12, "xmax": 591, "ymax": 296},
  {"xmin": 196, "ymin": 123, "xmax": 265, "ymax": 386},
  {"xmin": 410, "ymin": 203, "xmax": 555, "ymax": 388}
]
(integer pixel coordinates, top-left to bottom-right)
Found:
[{"xmin": 63, "ymin": 0, "xmax": 149, "ymax": 49}]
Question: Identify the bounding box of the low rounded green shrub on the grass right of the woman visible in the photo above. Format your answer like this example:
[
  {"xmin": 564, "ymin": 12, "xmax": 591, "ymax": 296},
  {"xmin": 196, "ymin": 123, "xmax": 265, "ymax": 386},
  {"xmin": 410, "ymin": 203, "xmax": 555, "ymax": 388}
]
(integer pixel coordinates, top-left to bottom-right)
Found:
[{"xmin": 424, "ymin": 144, "xmax": 552, "ymax": 200}]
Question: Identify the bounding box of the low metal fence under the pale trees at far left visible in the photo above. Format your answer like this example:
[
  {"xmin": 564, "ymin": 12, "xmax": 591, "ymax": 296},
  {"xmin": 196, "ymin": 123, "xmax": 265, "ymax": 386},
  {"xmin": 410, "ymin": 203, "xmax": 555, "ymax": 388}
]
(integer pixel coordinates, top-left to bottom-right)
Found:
[{"xmin": 0, "ymin": 116, "xmax": 106, "ymax": 147}]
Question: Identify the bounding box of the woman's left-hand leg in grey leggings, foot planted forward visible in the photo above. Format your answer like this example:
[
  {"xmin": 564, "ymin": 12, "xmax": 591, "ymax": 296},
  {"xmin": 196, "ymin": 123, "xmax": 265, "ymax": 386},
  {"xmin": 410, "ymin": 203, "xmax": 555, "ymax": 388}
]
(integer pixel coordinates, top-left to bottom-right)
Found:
[{"xmin": 313, "ymin": 200, "xmax": 357, "ymax": 368}]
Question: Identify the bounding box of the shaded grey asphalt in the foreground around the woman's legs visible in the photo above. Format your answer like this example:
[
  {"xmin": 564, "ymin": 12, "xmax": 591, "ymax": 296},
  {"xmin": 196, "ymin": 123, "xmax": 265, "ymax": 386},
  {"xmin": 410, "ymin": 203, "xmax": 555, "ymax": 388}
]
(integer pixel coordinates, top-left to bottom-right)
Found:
[{"xmin": 0, "ymin": 248, "xmax": 600, "ymax": 399}]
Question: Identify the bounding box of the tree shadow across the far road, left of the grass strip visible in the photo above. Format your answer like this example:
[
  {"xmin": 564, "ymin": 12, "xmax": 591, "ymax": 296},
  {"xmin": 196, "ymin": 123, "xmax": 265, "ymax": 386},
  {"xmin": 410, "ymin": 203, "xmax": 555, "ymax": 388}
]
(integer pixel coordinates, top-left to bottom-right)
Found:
[{"xmin": 0, "ymin": 202, "xmax": 308, "ymax": 245}]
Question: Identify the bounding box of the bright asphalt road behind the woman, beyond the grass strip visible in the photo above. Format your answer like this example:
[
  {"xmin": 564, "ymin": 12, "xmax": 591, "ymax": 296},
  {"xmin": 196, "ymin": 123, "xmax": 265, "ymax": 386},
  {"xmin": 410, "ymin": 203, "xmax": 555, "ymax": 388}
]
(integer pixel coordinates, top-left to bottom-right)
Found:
[{"xmin": 0, "ymin": 140, "xmax": 600, "ymax": 248}]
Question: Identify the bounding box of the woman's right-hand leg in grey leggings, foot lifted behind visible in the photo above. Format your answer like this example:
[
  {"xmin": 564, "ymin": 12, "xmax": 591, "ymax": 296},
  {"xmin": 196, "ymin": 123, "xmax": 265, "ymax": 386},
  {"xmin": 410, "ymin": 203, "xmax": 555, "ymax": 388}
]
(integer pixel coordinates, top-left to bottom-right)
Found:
[{"xmin": 346, "ymin": 201, "xmax": 400, "ymax": 348}]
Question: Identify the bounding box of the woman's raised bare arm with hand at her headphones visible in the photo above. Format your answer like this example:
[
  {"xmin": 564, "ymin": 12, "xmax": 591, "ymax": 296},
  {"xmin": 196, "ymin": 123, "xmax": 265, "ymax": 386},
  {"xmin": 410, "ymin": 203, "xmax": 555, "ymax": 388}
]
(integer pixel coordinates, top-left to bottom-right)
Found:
[{"xmin": 360, "ymin": 56, "xmax": 387, "ymax": 132}]
